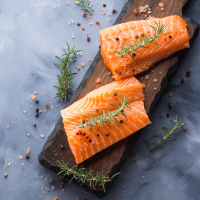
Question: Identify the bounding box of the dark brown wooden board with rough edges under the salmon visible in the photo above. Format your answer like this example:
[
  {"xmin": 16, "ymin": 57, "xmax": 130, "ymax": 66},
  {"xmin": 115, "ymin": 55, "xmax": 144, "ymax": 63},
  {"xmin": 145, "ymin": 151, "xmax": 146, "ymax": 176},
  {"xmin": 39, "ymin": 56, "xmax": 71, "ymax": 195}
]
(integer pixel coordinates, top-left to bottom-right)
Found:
[{"xmin": 38, "ymin": 0, "xmax": 198, "ymax": 197}]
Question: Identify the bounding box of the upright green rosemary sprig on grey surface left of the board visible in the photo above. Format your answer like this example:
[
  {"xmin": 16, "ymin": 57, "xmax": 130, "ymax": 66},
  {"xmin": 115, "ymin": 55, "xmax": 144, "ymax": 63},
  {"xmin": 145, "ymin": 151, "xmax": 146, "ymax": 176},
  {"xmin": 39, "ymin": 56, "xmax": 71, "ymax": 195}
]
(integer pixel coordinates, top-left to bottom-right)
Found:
[{"xmin": 54, "ymin": 42, "xmax": 81, "ymax": 101}]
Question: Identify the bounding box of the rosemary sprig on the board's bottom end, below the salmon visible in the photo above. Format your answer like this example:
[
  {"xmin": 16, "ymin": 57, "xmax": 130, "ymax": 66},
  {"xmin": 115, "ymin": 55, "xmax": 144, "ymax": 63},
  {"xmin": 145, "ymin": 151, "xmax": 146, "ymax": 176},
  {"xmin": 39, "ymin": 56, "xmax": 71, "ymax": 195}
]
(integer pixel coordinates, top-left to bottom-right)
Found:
[{"xmin": 58, "ymin": 160, "xmax": 121, "ymax": 192}]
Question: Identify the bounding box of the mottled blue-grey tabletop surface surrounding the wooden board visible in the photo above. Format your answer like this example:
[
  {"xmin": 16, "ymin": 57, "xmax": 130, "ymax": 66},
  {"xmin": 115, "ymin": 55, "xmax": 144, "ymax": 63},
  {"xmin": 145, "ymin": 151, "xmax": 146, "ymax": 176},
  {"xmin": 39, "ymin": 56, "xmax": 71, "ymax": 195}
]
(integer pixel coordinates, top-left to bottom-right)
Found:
[{"xmin": 0, "ymin": 0, "xmax": 200, "ymax": 200}]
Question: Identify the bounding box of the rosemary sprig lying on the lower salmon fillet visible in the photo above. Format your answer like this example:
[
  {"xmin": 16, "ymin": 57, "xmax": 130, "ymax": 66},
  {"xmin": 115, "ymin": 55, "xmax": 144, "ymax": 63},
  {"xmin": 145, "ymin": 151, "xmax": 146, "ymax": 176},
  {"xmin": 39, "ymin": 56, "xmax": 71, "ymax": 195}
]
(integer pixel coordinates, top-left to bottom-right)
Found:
[{"xmin": 77, "ymin": 95, "xmax": 133, "ymax": 132}]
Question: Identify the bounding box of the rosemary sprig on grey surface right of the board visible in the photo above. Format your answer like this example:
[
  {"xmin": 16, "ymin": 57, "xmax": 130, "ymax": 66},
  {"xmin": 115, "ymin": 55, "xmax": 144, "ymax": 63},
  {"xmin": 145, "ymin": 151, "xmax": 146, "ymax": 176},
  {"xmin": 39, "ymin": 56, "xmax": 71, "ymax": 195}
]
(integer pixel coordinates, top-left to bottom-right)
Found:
[{"xmin": 150, "ymin": 116, "xmax": 185, "ymax": 149}]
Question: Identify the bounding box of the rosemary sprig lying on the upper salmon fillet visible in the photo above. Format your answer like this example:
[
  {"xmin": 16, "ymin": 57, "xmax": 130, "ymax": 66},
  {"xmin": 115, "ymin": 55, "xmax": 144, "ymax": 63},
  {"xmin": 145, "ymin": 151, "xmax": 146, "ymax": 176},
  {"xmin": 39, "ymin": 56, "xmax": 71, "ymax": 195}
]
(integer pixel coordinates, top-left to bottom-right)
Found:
[{"xmin": 114, "ymin": 21, "xmax": 167, "ymax": 60}]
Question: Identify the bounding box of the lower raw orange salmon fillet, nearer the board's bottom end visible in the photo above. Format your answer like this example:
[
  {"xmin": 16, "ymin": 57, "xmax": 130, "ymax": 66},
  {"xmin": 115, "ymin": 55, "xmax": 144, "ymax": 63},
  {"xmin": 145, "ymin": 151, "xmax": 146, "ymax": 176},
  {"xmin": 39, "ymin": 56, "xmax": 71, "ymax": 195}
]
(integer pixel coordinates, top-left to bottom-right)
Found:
[{"xmin": 61, "ymin": 76, "xmax": 151, "ymax": 164}]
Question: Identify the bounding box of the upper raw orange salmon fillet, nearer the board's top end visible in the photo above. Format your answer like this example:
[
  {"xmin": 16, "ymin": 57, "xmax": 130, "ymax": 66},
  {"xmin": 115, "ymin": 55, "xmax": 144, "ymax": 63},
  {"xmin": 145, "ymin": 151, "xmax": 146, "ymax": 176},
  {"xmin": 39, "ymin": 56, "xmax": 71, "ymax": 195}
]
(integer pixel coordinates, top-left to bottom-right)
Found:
[{"xmin": 99, "ymin": 15, "xmax": 190, "ymax": 80}]
